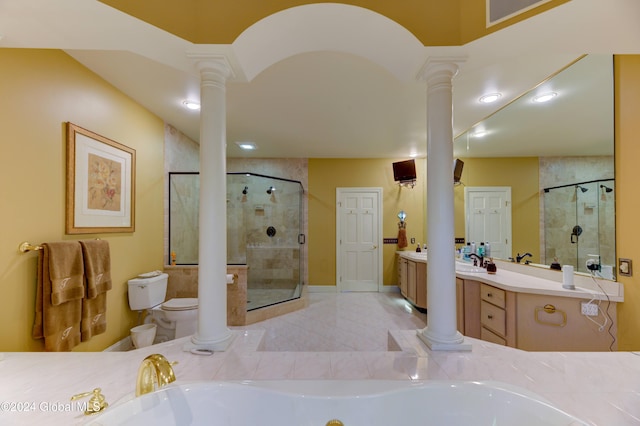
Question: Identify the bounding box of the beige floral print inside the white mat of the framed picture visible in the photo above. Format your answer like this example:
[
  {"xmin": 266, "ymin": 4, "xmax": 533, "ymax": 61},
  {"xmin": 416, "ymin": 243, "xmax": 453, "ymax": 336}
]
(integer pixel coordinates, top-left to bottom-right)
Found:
[{"xmin": 87, "ymin": 154, "xmax": 122, "ymax": 211}]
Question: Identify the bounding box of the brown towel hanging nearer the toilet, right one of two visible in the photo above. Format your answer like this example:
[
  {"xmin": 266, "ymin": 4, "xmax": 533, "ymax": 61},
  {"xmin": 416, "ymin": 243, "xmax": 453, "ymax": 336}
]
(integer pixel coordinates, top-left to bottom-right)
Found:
[{"xmin": 80, "ymin": 240, "xmax": 111, "ymax": 342}]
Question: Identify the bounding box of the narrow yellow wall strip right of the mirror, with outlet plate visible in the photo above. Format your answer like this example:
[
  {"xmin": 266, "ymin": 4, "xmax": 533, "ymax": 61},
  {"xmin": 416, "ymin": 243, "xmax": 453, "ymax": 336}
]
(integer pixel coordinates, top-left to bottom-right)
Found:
[{"xmin": 614, "ymin": 55, "xmax": 640, "ymax": 351}]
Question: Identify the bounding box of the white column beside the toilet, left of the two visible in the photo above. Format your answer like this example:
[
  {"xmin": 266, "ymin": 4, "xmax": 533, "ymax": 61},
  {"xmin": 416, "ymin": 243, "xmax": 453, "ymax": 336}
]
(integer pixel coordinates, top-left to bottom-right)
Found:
[{"xmin": 185, "ymin": 54, "xmax": 233, "ymax": 351}]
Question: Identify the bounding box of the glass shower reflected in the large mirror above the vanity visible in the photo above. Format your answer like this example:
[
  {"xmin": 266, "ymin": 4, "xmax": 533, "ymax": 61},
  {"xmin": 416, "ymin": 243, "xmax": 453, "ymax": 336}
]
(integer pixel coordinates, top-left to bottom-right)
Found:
[{"xmin": 543, "ymin": 179, "xmax": 615, "ymax": 279}]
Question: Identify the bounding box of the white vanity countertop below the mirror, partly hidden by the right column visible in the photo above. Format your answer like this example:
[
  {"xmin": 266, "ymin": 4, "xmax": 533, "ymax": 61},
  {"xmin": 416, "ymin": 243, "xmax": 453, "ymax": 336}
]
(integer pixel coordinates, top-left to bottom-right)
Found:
[{"xmin": 398, "ymin": 251, "xmax": 624, "ymax": 302}]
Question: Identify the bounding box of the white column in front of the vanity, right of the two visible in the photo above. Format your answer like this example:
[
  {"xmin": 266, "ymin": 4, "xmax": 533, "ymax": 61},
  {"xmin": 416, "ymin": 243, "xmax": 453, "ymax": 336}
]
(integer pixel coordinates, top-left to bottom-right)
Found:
[{"xmin": 418, "ymin": 57, "xmax": 471, "ymax": 351}]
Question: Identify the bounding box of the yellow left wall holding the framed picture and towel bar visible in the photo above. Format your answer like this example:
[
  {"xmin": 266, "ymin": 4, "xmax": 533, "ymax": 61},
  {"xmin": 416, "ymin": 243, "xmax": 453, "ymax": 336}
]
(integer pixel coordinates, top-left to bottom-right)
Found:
[{"xmin": 0, "ymin": 49, "xmax": 164, "ymax": 351}]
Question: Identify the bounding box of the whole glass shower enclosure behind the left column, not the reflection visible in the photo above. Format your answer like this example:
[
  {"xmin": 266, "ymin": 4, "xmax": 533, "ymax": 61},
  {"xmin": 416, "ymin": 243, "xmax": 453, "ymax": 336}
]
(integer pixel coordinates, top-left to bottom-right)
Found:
[{"xmin": 168, "ymin": 172, "xmax": 305, "ymax": 311}]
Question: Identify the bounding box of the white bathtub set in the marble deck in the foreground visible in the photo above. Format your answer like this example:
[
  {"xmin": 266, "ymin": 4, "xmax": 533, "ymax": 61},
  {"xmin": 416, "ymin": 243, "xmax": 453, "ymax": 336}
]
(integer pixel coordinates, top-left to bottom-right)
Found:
[{"xmin": 88, "ymin": 380, "xmax": 587, "ymax": 426}]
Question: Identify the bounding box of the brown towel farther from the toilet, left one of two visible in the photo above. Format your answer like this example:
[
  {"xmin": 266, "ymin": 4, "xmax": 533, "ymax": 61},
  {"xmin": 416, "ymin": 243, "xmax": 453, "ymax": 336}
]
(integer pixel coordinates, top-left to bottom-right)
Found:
[{"xmin": 32, "ymin": 241, "xmax": 84, "ymax": 351}]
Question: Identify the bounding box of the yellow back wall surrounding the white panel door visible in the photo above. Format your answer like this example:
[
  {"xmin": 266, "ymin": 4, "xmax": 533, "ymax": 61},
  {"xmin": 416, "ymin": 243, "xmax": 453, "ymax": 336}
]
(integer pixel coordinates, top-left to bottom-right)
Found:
[{"xmin": 308, "ymin": 158, "xmax": 426, "ymax": 285}]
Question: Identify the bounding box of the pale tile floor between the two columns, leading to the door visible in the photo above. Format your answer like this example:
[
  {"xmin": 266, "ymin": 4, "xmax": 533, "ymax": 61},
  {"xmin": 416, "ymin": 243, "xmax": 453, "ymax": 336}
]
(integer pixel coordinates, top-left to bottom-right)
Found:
[{"xmin": 233, "ymin": 293, "xmax": 426, "ymax": 352}]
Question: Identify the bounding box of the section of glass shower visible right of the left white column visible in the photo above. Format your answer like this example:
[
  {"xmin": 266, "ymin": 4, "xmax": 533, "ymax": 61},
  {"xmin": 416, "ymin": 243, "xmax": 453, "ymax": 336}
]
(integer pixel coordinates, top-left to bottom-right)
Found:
[{"xmin": 227, "ymin": 173, "xmax": 304, "ymax": 311}]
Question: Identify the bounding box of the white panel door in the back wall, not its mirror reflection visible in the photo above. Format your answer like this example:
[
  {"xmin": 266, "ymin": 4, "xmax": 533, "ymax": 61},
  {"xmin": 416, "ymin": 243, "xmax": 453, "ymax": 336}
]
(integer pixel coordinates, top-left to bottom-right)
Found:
[{"xmin": 336, "ymin": 188, "xmax": 382, "ymax": 291}]
